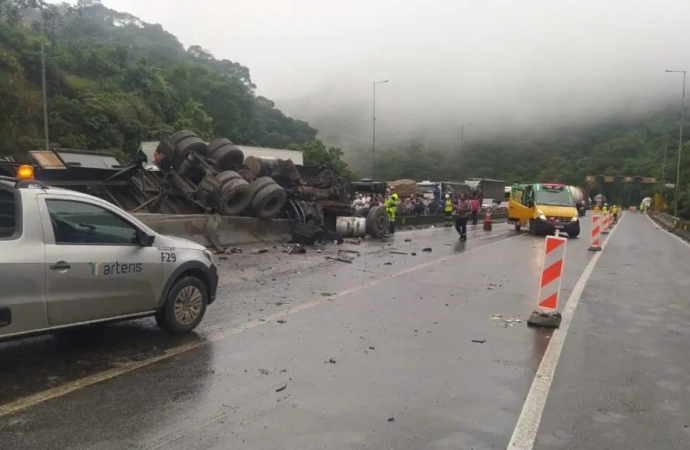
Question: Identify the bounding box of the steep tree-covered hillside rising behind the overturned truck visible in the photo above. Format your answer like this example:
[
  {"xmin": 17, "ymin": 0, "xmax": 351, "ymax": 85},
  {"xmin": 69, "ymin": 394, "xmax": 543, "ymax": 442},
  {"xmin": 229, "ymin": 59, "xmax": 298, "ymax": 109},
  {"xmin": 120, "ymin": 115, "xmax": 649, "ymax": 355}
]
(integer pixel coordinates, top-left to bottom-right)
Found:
[{"xmin": 0, "ymin": 0, "xmax": 349, "ymax": 175}]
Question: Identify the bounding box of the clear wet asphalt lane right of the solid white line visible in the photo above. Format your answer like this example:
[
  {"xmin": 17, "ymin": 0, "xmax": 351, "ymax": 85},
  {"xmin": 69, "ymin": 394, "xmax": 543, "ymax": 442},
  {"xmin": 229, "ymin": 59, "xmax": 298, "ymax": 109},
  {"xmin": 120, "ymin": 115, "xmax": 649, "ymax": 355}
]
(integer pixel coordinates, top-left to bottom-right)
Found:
[{"xmin": 534, "ymin": 213, "xmax": 690, "ymax": 450}]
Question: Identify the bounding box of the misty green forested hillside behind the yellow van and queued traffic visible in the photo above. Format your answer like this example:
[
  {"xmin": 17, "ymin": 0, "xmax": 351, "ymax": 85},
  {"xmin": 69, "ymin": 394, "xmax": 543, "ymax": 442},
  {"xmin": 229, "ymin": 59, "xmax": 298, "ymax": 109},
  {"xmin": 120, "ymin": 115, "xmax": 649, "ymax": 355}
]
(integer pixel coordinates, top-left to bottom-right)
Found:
[{"xmin": 347, "ymin": 105, "xmax": 690, "ymax": 216}]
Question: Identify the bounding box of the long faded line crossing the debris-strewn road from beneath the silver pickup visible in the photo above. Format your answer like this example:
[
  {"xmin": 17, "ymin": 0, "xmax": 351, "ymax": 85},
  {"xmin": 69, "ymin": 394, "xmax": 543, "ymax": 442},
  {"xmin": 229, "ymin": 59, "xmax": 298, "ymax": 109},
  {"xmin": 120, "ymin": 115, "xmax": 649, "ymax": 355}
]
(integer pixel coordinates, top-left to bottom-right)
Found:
[{"xmin": 0, "ymin": 234, "xmax": 526, "ymax": 418}]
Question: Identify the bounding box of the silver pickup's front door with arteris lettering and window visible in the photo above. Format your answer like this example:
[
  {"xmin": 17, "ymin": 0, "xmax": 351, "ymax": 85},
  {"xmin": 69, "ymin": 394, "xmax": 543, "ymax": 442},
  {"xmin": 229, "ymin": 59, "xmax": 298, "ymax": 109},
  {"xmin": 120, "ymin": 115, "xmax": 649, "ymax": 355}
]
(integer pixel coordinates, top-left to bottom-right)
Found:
[{"xmin": 38, "ymin": 194, "xmax": 163, "ymax": 326}]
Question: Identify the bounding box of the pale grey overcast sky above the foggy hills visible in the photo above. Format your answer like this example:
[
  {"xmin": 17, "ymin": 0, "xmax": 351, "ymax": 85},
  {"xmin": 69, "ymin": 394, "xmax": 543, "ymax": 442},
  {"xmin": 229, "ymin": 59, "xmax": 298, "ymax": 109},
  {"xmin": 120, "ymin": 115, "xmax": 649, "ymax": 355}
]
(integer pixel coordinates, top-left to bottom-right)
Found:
[{"xmin": 103, "ymin": 0, "xmax": 690, "ymax": 142}]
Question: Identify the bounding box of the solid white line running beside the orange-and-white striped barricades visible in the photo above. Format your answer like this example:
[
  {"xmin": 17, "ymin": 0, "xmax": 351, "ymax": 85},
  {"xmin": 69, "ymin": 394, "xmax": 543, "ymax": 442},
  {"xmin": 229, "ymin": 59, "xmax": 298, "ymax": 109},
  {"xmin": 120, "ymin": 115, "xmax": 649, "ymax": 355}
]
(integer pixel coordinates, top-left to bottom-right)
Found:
[{"xmin": 508, "ymin": 214, "xmax": 625, "ymax": 450}]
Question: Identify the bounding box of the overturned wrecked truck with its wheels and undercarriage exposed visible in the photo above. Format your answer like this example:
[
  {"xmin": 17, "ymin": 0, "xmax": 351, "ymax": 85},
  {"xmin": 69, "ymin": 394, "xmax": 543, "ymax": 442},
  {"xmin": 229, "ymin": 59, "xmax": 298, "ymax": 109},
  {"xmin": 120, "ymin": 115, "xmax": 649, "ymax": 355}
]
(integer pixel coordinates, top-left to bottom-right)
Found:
[{"xmin": 0, "ymin": 130, "xmax": 389, "ymax": 243}]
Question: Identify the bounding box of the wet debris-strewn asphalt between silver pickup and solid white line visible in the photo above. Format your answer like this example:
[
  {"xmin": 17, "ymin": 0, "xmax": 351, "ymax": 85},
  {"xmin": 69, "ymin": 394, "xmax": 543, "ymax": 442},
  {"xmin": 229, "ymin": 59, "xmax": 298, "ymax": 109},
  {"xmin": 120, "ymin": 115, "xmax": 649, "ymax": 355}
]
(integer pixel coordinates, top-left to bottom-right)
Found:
[{"xmin": 0, "ymin": 219, "xmax": 612, "ymax": 450}]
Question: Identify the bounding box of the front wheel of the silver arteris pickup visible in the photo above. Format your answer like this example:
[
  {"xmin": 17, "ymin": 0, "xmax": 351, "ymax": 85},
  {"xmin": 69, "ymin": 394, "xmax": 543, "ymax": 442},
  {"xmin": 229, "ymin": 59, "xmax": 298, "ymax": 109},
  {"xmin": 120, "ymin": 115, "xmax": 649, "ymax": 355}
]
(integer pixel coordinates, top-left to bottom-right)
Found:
[{"xmin": 156, "ymin": 277, "xmax": 208, "ymax": 334}]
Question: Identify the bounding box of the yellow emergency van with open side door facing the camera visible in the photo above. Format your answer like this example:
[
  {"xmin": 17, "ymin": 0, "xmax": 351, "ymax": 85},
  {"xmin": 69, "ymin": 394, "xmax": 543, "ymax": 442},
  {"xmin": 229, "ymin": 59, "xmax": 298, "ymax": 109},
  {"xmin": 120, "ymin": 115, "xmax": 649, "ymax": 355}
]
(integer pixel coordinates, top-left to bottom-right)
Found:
[{"xmin": 508, "ymin": 183, "xmax": 580, "ymax": 237}]
